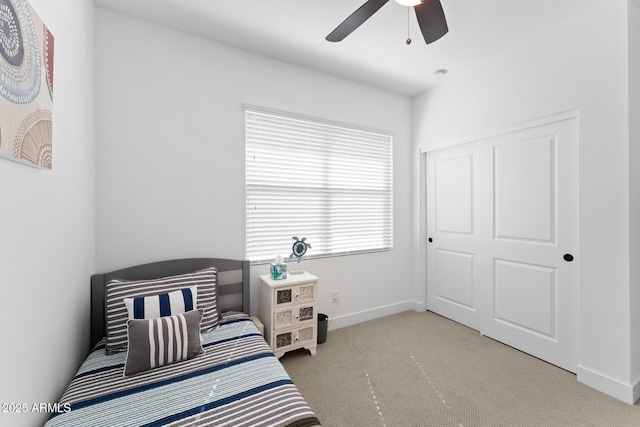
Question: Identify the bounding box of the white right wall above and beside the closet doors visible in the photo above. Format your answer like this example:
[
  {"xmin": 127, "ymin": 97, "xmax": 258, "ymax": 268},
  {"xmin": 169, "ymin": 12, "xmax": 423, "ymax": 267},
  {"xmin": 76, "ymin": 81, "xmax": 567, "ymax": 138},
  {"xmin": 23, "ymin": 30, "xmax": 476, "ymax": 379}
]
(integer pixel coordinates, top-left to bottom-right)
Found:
[{"xmin": 413, "ymin": 0, "xmax": 640, "ymax": 401}]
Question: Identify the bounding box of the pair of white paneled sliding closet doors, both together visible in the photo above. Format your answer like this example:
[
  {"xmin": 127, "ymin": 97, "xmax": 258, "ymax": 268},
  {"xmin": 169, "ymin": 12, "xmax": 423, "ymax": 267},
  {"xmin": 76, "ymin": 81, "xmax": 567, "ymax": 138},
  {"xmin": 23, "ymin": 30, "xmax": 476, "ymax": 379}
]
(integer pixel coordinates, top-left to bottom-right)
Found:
[{"xmin": 427, "ymin": 115, "xmax": 579, "ymax": 372}]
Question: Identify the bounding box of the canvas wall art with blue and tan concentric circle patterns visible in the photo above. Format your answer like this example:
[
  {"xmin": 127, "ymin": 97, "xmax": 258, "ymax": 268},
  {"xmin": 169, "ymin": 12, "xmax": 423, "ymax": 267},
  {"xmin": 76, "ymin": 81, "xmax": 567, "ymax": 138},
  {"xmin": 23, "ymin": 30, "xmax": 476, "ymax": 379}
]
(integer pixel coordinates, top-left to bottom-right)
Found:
[{"xmin": 0, "ymin": 0, "xmax": 53, "ymax": 169}]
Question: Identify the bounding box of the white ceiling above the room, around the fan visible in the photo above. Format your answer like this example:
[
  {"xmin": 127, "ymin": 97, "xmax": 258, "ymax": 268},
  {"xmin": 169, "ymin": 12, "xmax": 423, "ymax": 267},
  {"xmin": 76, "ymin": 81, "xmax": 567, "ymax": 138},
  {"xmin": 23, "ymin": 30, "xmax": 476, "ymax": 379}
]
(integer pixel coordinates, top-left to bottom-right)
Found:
[{"xmin": 95, "ymin": 0, "xmax": 602, "ymax": 97}]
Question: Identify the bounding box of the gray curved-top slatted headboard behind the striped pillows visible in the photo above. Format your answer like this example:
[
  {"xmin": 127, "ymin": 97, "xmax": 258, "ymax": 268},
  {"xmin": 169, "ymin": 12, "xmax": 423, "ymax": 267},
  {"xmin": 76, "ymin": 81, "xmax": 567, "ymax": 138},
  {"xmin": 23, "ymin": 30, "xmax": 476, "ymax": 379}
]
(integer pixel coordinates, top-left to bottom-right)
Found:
[{"xmin": 91, "ymin": 258, "xmax": 250, "ymax": 347}]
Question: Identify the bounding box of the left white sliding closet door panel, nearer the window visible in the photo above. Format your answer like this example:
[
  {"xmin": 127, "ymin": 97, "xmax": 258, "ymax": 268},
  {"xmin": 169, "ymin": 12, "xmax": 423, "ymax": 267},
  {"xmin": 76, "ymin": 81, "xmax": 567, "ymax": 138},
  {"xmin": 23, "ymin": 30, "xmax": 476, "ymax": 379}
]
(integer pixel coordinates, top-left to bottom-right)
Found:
[{"xmin": 427, "ymin": 143, "xmax": 480, "ymax": 329}]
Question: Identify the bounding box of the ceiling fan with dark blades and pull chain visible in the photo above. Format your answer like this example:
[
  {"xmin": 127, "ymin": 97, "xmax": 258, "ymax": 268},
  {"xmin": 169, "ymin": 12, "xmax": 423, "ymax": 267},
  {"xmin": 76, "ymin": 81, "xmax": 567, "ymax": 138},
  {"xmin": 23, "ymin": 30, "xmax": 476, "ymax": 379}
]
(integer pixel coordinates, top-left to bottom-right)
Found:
[{"xmin": 326, "ymin": 0, "xmax": 449, "ymax": 44}]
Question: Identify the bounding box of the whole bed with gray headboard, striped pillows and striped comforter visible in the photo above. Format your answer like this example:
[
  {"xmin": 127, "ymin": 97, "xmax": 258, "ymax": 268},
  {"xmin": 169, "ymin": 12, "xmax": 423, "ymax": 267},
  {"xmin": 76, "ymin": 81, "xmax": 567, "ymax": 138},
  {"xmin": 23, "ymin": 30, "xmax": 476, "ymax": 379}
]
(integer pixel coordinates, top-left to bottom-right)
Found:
[{"xmin": 46, "ymin": 258, "xmax": 320, "ymax": 427}]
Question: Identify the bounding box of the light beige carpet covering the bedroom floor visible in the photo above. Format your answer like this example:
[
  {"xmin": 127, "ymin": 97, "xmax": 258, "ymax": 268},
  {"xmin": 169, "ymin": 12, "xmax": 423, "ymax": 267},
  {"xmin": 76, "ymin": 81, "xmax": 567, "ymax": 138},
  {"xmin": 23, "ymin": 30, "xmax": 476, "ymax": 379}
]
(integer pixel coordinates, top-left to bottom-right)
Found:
[{"xmin": 280, "ymin": 311, "xmax": 640, "ymax": 427}]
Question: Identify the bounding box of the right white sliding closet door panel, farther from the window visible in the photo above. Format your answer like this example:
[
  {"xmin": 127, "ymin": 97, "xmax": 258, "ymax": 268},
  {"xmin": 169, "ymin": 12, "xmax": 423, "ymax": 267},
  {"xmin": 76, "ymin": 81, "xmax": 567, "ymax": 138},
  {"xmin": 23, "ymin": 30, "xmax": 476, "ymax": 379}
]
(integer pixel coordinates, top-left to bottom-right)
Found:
[{"xmin": 478, "ymin": 120, "xmax": 579, "ymax": 372}]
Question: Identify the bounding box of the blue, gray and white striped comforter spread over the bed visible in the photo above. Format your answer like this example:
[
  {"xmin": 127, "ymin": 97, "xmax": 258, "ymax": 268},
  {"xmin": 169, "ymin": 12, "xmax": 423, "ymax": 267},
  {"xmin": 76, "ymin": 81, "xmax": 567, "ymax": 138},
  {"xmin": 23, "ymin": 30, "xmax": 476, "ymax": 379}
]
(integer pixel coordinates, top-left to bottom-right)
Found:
[{"xmin": 45, "ymin": 314, "xmax": 320, "ymax": 427}]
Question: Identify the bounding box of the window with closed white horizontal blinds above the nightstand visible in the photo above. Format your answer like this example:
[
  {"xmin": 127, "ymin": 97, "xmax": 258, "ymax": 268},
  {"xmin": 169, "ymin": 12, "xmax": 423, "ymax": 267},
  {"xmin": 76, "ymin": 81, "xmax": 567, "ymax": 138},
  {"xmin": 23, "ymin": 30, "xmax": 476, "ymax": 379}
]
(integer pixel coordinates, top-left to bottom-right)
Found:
[{"xmin": 245, "ymin": 109, "xmax": 393, "ymax": 262}]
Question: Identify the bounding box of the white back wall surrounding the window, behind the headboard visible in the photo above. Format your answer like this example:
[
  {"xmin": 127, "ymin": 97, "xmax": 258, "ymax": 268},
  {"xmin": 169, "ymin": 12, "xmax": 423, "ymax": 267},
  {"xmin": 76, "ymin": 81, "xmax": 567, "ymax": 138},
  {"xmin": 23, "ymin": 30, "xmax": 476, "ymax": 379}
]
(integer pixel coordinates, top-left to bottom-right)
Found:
[{"xmin": 96, "ymin": 8, "xmax": 414, "ymax": 327}]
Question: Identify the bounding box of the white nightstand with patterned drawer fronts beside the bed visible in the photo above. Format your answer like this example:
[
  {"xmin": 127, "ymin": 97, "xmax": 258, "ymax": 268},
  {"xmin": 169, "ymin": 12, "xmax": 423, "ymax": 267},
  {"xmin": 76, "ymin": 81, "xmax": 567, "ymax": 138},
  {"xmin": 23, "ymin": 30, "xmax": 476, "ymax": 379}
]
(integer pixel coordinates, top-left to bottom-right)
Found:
[{"xmin": 260, "ymin": 272, "xmax": 319, "ymax": 358}]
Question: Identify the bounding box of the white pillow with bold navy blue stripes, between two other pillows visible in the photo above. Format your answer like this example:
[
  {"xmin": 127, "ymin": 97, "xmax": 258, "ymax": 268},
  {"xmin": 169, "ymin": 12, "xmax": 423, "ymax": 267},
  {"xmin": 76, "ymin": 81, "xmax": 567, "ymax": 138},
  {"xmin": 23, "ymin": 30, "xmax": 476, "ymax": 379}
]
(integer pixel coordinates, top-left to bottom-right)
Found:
[{"xmin": 124, "ymin": 286, "xmax": 198, "ymax": 319}]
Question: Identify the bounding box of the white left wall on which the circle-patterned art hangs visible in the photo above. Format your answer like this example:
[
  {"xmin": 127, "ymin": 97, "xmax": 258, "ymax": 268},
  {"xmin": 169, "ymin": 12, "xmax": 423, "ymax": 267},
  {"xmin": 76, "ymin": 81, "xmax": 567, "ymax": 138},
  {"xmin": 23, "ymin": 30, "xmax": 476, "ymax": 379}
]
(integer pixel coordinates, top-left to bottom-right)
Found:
[{"xmin": 0, "ymin": 0, "xmax": 95, "ymax": 426}]
